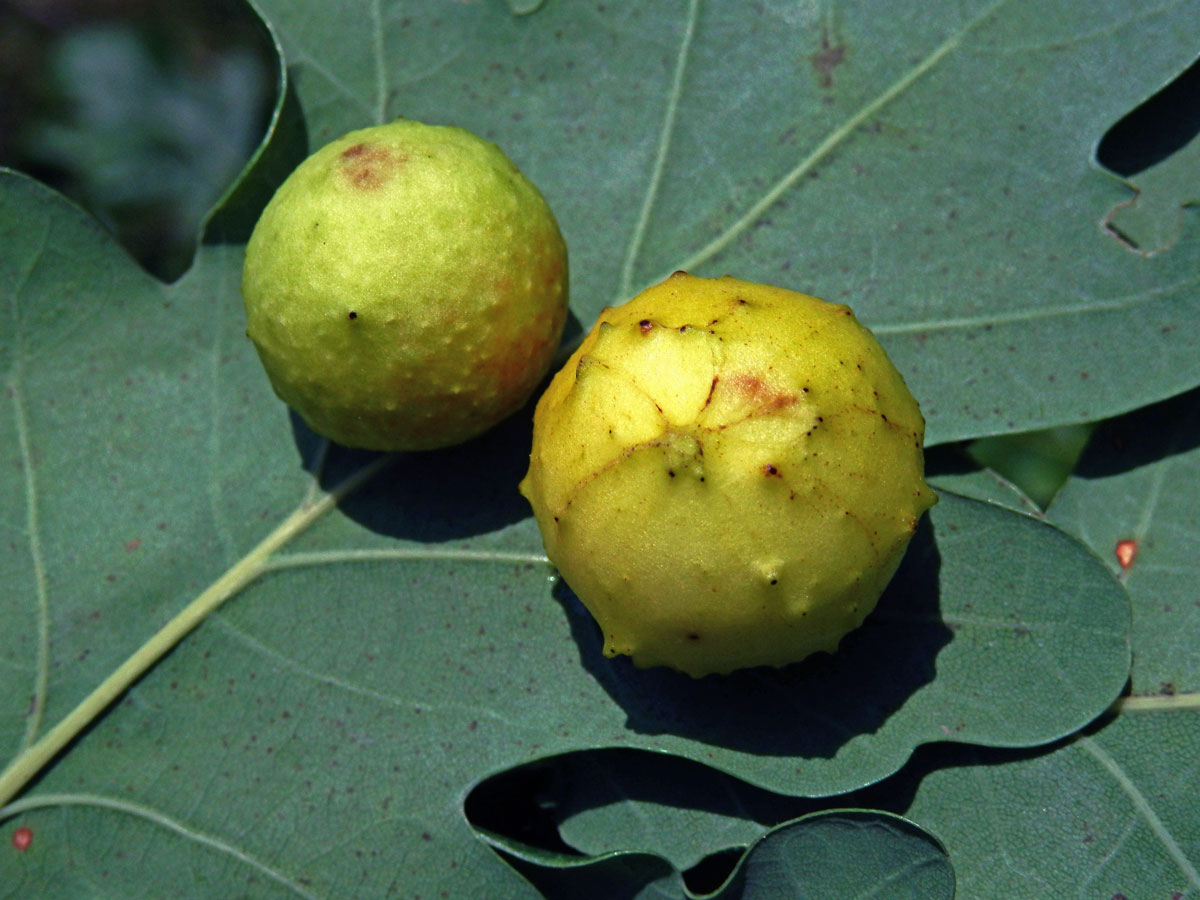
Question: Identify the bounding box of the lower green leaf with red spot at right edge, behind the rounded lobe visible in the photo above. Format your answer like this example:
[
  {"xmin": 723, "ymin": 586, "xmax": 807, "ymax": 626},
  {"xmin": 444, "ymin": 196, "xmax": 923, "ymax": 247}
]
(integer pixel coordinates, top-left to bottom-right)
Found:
[{"xmin": 906, "ymin": 390, "xmax": 1200, "ymax": 900}]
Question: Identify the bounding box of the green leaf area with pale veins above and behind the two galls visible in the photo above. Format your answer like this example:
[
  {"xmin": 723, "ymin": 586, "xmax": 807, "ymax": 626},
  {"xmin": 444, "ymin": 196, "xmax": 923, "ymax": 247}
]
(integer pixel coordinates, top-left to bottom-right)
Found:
[{"xmin": 248, "ymin": 0, "xmax": 1200, "ymax": 444}]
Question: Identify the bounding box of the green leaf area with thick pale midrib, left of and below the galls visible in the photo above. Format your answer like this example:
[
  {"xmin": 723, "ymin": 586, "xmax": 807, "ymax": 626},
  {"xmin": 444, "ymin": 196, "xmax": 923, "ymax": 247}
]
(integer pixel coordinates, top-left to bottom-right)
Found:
[{"xmin": 0, "ymin": 168, "xmax": 1128, "ymax": 895}]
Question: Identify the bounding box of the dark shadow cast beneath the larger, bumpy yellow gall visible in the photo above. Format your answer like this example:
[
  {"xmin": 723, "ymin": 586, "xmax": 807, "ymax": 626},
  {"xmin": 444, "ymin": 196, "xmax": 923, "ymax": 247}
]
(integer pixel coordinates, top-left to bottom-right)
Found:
[{"xmin": 554, "ymin": 516, "xmax": 953, "ymax": 758}]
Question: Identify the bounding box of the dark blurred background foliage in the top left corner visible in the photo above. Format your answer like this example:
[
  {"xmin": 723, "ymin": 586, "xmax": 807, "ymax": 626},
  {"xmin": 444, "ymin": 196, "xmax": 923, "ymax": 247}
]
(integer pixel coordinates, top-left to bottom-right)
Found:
[{"xmin": 0, "ymin": 0, "xmax": 275, "ymax": 281}]
